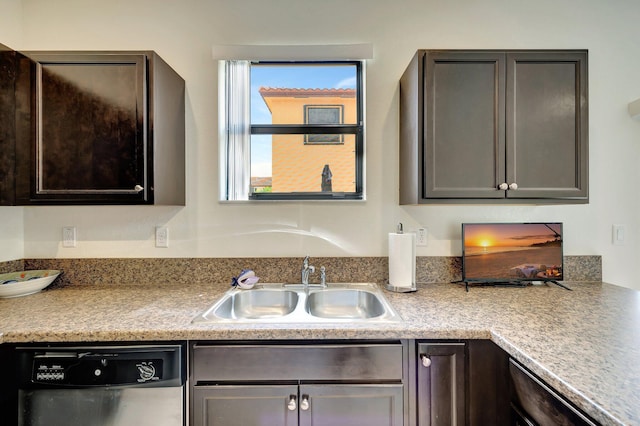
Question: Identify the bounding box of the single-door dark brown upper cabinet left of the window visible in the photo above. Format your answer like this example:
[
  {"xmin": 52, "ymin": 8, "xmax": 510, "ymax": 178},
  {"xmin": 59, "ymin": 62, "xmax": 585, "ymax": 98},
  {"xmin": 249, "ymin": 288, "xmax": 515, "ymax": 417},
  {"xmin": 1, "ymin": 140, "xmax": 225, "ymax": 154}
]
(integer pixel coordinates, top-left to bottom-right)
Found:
[{"xmin": 15, "ymin": 51, "xmax": 185, "ymax": 205}]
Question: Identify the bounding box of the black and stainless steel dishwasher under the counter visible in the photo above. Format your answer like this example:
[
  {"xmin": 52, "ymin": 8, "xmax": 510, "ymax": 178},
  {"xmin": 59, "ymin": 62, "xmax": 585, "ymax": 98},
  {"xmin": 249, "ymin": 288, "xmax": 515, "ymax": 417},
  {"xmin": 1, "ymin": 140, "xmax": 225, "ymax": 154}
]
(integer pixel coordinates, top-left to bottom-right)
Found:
[{"xmin": 16, "ymin": 344, "xmax": 186, "ymax": 426}]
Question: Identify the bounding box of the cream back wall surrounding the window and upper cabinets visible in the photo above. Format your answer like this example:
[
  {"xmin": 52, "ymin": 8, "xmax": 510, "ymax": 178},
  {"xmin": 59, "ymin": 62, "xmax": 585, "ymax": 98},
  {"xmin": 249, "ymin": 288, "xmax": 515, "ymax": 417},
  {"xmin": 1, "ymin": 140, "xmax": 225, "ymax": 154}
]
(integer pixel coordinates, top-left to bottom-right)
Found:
[{"xmin": 5, "ymin": 0, "xmax": 640, "ymax": 288}]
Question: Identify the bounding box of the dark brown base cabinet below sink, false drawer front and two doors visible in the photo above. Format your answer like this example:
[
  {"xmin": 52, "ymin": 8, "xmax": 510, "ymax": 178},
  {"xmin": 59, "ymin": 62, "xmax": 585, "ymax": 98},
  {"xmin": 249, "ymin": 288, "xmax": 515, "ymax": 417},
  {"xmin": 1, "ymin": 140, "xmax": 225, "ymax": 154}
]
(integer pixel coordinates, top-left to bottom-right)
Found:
[{"xmin": 190, "ymin": 341, "xmax": 407, "ymax": 426}]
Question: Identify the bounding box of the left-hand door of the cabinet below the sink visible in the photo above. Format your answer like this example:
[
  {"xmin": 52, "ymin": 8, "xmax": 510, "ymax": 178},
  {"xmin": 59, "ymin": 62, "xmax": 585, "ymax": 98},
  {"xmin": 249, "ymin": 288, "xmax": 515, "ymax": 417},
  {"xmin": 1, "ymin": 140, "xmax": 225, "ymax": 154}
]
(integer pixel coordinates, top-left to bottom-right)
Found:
[{"xmin": 191, "ymin": 385, "xmax": 298, "ymax": 426}]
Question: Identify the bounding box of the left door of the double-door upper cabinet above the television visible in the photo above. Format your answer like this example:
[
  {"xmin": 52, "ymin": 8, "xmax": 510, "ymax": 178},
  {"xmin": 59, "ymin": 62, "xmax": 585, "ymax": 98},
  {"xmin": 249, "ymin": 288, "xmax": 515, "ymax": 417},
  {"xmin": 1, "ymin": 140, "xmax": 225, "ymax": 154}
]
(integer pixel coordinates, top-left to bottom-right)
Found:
[{"xmin": 423, "ymin": 51, "xmax": 505, "ymax": 198}]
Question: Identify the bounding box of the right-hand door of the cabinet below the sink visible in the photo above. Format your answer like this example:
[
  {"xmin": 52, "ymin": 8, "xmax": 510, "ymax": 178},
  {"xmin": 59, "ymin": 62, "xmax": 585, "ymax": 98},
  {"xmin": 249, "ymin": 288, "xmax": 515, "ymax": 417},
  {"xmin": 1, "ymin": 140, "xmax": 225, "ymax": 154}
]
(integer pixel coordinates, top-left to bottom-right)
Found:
[{"xmin": 302, "ymin": 384, "xmax": 404, "ymax": 426}]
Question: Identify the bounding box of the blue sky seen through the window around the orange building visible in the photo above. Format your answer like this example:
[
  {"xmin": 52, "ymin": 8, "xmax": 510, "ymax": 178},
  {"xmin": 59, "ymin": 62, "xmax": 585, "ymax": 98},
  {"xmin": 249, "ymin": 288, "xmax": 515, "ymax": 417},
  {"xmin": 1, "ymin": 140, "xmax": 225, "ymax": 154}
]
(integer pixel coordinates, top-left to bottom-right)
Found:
[{"xmin": 251, "ymin": 65, "xmax": 356, "ymax": 177}]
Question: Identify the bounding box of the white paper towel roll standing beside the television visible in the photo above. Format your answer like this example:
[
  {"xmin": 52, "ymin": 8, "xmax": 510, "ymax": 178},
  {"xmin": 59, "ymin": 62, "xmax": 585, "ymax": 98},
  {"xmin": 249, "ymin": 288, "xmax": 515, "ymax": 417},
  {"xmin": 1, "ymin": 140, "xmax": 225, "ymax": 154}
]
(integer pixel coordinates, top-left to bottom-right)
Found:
[{"xmin": 389, "ymin": 233, "xmax": 416, "ymax": 288}]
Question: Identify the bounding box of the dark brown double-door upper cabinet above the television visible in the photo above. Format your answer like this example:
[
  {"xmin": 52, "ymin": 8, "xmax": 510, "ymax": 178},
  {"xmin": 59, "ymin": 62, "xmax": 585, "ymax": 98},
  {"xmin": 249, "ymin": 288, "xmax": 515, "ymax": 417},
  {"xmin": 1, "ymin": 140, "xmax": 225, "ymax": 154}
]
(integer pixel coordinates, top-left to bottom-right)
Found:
[{"xmin": 399, "ymin": 50, "xmax": 589, "ymax": 204}]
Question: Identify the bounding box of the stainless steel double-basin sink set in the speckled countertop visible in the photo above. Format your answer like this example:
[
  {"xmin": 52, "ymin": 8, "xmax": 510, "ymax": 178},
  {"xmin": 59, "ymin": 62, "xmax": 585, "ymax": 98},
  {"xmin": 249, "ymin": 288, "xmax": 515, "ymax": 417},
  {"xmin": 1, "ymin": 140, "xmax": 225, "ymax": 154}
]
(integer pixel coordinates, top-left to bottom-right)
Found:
[{"xmin": 193, "ymin": 283, "xmax": 401, "ymax": 323}]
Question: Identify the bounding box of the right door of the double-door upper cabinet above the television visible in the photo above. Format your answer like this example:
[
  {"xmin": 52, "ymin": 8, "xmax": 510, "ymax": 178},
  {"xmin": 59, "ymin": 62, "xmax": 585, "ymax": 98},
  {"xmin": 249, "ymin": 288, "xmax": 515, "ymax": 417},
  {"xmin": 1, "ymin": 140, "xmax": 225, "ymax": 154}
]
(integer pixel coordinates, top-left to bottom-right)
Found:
[{"xmin": 506, "ymin": 51, "xmax": 588, "ymax": 199}]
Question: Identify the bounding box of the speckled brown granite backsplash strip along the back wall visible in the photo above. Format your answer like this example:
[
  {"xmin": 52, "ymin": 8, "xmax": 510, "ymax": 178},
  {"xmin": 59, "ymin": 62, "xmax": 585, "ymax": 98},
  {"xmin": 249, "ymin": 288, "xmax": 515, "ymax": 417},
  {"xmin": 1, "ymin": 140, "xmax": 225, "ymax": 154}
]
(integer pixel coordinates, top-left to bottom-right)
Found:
[{"xmin": 0, "ymin": 256, "xmax": 602, "ymax": 285}]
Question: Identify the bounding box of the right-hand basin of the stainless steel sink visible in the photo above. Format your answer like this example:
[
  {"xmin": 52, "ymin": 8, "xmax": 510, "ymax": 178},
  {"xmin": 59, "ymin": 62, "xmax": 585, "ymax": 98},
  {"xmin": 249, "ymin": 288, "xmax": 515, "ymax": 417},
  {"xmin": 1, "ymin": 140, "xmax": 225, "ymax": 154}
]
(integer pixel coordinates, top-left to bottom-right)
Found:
[{"xmin": 307, "ymin": 289, "xmax": 385, "ymax": 319}]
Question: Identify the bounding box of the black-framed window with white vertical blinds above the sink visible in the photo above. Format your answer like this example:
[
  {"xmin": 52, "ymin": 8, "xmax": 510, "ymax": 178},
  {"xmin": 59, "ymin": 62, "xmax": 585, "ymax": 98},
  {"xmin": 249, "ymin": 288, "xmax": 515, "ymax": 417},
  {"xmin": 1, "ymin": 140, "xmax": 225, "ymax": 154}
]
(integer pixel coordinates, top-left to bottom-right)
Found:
[{"xmin": 220, "ymin": 61, "xmax": 364, "ymax": 200}]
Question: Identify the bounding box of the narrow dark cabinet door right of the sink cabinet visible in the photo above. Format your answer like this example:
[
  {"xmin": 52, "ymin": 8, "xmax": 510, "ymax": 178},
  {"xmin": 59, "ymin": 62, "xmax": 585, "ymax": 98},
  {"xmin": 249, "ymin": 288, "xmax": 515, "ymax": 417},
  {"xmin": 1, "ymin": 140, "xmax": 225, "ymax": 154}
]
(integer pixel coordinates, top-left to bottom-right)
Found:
[{"xmin": 417, "ymin": 342, "xmax": 466, "ymax": 426}]
